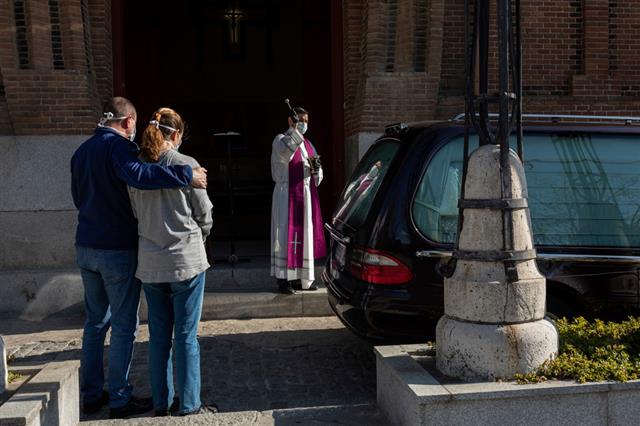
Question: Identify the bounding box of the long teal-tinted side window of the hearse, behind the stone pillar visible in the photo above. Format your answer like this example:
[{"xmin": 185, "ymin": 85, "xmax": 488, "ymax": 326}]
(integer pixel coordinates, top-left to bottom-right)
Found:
[{"xmin": 412, "ymin": 133, "xmax": 640, "ymax": 247}]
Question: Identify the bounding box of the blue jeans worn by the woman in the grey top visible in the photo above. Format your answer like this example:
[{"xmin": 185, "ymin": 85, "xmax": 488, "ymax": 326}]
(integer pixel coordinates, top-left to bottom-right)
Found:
[{"xmin": 143, "ymin": 272, "xmax": 205, "ymax": 414}]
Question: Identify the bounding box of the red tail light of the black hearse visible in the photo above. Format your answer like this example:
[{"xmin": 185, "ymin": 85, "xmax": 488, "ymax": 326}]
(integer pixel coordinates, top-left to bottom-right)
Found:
[{"xmin": 349, "ymin": 248, "xmax": 413, "ymax": 285}]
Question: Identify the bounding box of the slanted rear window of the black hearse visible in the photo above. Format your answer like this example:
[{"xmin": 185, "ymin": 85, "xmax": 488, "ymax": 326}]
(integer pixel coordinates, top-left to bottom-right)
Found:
[{"xmin": 333, "ymin": 139, "xmax": 400, "ymax": 228}]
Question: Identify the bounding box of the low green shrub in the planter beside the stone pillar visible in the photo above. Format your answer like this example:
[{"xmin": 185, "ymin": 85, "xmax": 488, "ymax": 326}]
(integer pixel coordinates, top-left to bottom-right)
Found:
[{"xmin": 515, "ymin": 317, "xmax": 640, "ymax": 383}]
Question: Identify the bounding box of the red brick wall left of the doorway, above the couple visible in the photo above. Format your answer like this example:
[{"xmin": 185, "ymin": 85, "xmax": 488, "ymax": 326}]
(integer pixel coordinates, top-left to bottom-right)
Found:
[{"xmin": 0, "ymin": 0, "xmax": 112, "ymax": 135}]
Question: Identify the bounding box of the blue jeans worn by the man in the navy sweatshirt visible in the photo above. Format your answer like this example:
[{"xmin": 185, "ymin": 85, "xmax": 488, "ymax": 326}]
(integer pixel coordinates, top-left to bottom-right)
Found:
[{"xmin": 76, "ymin": 246, "xmax": 140, "ymax": 408}]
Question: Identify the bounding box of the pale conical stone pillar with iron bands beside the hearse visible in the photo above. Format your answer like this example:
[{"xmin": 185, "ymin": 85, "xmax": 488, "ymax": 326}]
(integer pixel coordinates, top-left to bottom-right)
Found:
[{"xmin": 436, "ymin": 145, "xmax": 558, "ymax": 380}]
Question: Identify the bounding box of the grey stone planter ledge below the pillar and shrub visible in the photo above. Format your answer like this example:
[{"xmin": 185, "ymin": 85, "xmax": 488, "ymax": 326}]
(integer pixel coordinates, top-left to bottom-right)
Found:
[{"xmin": 374, "ymin": 345, "xmax": 640, "ymax": 426}]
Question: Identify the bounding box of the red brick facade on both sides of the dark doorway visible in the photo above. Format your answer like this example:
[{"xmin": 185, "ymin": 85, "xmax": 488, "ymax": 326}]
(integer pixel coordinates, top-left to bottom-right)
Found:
[{"xmin": 0, "ymin": 0, "xmax": 640, "ymax": 136}]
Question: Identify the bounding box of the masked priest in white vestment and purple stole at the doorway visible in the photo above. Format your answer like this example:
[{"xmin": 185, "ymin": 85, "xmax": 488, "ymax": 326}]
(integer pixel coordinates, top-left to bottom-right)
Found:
[{"xmin": 271, "ymin": 107, "xmax": 326, "ymax": 294}]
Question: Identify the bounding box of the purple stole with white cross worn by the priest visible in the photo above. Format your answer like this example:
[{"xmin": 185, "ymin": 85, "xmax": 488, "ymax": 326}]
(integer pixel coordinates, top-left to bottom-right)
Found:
[{"xmin": 287, "ymin": 139, "xmax": 326, "ymax": 269}]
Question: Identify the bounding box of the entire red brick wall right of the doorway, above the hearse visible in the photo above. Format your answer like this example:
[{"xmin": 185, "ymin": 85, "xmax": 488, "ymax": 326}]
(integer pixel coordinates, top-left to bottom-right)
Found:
[{"xmin": 344, "ymin": 0, "xmax": 640, "ymax": 135}]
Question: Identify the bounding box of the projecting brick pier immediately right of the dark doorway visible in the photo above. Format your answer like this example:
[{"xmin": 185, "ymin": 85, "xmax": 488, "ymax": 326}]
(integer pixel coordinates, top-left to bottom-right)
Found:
[{"xmin": 344, "ymin": 0, "xmax": 444, "ymax": 135}]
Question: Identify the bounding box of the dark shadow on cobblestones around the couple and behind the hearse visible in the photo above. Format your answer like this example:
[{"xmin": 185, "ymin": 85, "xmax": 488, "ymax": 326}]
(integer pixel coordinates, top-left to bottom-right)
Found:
[{"xmin": 8, "ymin": 326, "xmax": 376, "ymax": 420}]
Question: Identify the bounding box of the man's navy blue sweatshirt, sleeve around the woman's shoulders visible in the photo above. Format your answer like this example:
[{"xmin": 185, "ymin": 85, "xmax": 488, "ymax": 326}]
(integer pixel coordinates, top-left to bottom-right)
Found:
[{"xmin": 71, "ymin": 127, "xmax": 193, "ymax": 250}]
